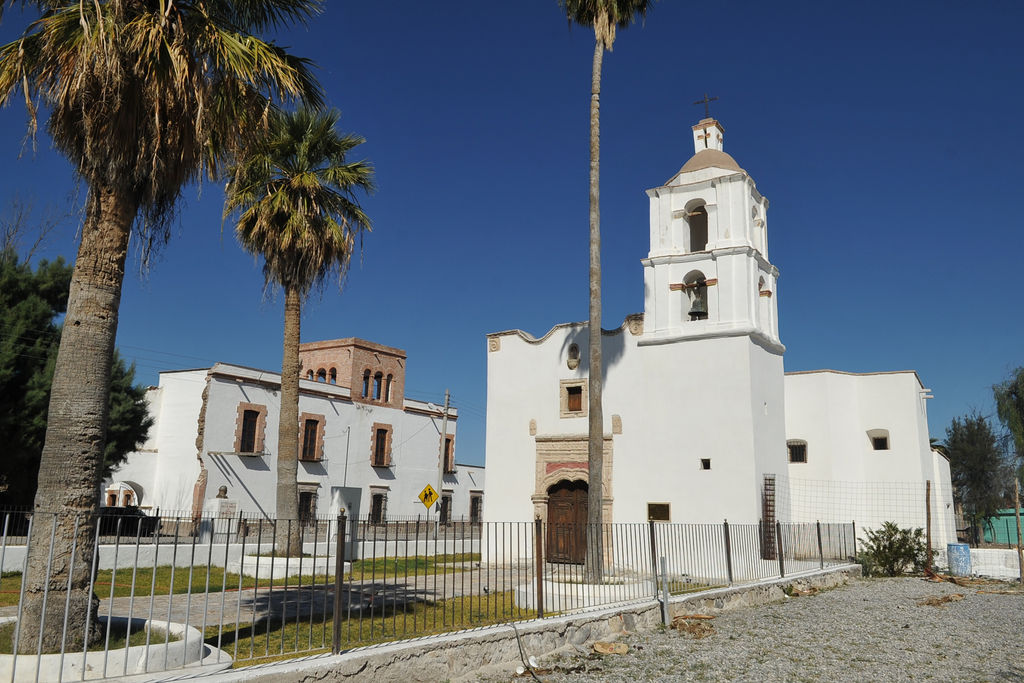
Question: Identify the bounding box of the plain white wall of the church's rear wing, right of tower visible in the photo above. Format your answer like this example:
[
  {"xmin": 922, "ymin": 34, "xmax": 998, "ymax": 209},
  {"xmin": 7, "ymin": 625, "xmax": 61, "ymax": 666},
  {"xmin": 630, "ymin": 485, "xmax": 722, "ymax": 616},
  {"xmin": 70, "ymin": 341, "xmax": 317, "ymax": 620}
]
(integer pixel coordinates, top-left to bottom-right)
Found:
[{"xmin": 785, "ymin": 371, "xmax": 955, "ymax": 544}]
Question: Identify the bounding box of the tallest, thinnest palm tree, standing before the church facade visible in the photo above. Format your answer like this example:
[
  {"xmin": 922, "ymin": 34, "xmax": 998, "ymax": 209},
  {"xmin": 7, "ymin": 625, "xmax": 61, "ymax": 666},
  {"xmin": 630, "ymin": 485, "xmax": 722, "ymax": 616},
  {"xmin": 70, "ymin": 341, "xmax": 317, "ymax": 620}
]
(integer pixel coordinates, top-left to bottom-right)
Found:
[{"xmin": 558, "ymin": 0, "xmax": 651, "ymax": 581}]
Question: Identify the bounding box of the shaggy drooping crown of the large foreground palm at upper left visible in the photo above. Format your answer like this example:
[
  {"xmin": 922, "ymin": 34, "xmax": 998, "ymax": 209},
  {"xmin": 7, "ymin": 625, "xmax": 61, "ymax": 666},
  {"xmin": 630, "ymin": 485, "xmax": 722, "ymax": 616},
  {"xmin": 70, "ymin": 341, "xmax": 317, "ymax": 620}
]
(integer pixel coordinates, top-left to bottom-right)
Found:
[{"xmin": 0, "ymin": 0, "xmax": 323, "ymax": 250}]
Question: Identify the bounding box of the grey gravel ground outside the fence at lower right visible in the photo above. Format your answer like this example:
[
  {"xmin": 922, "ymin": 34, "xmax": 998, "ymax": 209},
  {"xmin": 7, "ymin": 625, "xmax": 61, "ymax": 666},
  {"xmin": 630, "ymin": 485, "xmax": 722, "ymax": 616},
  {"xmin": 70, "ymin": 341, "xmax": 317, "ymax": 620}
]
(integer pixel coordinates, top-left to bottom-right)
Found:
[{"xmin": 518, "ymin": 579, "xmax": 1024, "ymax": 683}]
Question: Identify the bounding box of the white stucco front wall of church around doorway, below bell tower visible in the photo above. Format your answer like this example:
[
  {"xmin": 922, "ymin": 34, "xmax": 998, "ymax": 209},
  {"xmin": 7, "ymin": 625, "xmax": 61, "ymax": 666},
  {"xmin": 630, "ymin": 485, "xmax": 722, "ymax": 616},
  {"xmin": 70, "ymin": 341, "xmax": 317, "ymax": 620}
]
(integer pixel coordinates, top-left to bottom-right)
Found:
[{"xmin": 484, "ymin": 317, "xmax": 785, "ymax": 522}]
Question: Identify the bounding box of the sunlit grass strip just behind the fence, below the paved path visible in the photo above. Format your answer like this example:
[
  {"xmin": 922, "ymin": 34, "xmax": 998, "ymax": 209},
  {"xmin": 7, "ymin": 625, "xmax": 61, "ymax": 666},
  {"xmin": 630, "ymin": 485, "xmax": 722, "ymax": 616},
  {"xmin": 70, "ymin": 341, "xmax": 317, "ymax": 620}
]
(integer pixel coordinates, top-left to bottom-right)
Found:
[{"xmin": 206, "ymin": 591, "xmax": 537, "ymax": 667}]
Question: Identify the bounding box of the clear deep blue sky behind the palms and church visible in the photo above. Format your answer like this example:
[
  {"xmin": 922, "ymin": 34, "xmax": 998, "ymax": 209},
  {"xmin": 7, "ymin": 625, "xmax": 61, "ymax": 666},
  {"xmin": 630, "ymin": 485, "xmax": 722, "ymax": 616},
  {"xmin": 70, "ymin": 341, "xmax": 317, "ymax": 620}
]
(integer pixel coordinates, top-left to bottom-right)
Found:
[{"xmin": 0, "ymin": 0, "xmax": 1024, "ymax": 471}]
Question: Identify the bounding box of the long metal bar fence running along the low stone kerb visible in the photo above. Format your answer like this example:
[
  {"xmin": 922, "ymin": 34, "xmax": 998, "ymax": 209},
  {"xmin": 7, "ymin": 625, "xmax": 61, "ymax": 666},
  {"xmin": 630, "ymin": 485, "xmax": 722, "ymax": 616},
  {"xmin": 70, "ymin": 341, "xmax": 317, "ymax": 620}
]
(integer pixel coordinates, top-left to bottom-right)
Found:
[{"xmin": 0, "ymin": 513, "xmax": 856, "ymax": 681}]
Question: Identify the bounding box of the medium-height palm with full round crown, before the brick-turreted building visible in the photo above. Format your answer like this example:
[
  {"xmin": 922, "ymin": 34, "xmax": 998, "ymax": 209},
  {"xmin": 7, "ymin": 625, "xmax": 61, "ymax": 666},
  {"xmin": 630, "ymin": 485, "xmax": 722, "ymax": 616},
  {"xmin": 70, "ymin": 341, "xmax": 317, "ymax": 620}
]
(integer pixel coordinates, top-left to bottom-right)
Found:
[{"xmin": 224, "ymin": 109, "xmax": 374, "ymax": 556}]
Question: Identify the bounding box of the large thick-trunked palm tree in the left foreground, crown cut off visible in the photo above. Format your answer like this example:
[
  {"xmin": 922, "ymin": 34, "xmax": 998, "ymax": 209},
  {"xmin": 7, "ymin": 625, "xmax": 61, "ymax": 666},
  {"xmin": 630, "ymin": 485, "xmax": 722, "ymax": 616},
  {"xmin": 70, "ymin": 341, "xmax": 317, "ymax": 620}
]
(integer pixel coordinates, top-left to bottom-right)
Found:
[{"xmin": 0, "ymin": 0, "xmax": 321, "ymax": 652}]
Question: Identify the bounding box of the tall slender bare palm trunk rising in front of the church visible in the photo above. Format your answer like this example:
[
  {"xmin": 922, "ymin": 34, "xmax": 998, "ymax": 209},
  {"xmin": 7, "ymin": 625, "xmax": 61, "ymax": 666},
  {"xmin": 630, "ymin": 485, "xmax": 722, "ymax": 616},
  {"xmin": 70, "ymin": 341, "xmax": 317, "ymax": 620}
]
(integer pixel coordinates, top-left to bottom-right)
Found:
[{"xmin": 585, "ymin": 36, "xmax": 604, "ymax": 582}]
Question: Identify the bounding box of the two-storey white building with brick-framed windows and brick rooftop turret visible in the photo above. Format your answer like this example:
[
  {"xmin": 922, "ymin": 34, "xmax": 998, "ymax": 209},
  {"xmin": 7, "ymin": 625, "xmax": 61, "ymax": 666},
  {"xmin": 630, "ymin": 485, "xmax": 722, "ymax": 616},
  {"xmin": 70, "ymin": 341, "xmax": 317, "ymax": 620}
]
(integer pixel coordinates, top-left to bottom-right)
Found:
[{"xmin": 103, "ymin": 338, "xmax": 483, "ymax": 521}]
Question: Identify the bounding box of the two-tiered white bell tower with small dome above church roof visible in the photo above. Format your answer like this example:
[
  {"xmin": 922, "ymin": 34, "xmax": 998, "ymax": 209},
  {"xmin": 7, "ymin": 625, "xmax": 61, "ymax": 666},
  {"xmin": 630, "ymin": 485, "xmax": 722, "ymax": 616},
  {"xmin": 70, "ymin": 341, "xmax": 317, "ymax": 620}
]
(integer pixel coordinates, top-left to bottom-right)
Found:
[{"xmin": 641, "ymin": 117, "xmax": 785, "ymax": 354}]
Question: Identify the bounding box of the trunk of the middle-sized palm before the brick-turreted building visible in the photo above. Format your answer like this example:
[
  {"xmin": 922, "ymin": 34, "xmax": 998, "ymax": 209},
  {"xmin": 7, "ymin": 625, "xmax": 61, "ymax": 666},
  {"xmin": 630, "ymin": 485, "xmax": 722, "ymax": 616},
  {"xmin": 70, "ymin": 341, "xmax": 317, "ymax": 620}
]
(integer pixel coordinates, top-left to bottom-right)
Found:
[{"xmin": 274, "ymin": 287, "xmax": 302, "ymax": 557}]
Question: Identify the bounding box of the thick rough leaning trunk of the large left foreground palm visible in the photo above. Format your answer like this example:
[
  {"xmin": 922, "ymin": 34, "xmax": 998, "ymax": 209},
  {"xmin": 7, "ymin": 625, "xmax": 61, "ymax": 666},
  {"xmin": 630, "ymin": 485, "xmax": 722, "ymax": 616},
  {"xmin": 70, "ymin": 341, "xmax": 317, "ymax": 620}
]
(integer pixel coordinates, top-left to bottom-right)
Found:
[{"xmin": 18, "ymin": 187, "xmax": 137, "ymax": 653}]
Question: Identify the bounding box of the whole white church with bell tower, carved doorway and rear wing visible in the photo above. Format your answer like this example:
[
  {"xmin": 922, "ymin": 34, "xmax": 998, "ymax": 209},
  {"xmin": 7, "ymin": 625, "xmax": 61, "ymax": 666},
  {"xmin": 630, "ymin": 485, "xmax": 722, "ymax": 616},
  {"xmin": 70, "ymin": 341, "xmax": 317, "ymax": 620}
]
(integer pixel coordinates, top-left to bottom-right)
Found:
[{"xmin": 484, "ymin": 119, "xmax": 955, "ymax": 541}]
